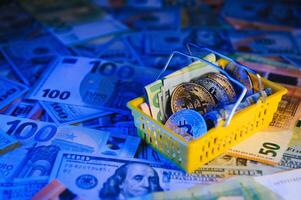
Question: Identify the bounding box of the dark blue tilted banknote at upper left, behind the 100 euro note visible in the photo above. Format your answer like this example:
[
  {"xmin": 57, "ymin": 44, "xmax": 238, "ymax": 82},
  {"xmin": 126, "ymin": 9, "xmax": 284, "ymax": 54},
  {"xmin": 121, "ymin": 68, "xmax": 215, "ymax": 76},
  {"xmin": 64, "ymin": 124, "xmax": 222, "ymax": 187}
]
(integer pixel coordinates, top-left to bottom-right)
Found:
[{"xmin": 2, "ymin": 33, "xmax": 70, "ymax": 85}]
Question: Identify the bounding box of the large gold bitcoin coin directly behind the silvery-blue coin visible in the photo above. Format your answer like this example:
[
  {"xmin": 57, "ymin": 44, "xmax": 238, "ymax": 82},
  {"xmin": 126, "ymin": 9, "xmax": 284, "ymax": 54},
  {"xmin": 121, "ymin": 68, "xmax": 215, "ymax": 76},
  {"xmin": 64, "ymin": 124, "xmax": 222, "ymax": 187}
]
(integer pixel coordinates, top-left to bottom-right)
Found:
[{"xmin": 170, "ymin": 83, "xmax": 216, "ymax": 114}]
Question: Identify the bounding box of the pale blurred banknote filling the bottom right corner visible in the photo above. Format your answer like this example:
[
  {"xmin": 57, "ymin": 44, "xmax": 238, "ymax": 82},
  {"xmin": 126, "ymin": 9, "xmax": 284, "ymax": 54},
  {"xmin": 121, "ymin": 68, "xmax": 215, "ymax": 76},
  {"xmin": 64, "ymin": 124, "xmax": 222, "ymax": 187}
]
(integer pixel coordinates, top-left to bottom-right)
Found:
[{"xmin": 145, "ymin": 169, "xmax": 301, "ymax": 200}]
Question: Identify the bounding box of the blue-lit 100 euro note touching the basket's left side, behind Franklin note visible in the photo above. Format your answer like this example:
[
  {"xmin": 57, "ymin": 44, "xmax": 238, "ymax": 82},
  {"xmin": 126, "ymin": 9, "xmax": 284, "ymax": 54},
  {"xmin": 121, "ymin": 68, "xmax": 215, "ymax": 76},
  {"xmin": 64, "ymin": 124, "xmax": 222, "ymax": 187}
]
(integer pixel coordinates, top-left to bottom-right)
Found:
[{"xmin": 29, "ymin": 57, "xmax": 159, "ymax": 112}]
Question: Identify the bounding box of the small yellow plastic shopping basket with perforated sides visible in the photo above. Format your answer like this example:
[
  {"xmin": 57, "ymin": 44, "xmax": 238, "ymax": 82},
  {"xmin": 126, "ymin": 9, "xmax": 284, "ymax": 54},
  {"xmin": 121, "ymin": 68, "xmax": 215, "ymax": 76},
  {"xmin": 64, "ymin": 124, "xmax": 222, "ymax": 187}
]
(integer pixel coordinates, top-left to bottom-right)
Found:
[{"xmin": 127, "ymin": 47, "xmax": 287, "ymax": 173}]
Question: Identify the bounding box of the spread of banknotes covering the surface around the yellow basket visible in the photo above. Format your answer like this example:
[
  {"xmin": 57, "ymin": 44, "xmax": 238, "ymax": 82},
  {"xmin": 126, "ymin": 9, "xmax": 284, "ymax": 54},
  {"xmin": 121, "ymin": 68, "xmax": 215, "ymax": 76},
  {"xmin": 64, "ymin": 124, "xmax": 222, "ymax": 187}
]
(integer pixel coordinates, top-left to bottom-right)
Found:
[{"xmin": 0, "ymin": 0, "xmax": 301, "ymax": 199}]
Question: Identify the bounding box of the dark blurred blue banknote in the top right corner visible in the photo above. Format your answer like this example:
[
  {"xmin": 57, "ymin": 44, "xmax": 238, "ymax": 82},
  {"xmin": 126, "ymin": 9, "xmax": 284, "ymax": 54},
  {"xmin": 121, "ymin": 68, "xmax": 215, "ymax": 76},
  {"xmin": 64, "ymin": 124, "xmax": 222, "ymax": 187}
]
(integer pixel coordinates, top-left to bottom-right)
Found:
[{"xmin": 223, "ymin": 0, "xmax": 301, "ymax": 30}]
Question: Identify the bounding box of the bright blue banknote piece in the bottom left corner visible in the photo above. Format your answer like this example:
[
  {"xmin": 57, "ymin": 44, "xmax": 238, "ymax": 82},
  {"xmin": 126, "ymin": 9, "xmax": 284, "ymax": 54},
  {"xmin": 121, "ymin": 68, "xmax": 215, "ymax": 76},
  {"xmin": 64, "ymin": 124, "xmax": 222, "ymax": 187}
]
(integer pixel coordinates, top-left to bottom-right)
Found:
[{"xmin": 0, "ymin": 177, "xmax": 48, "ymax": 200}]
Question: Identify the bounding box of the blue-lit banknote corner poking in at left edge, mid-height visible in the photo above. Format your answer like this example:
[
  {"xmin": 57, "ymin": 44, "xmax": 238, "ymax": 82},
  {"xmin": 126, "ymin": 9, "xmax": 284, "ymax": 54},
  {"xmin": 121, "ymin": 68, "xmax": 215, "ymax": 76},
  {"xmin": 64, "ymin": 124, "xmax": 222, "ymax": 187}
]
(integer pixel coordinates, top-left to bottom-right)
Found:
[{"xmin": 0, "ymin": 76, "xmax": 28, "ymax": 109}]
